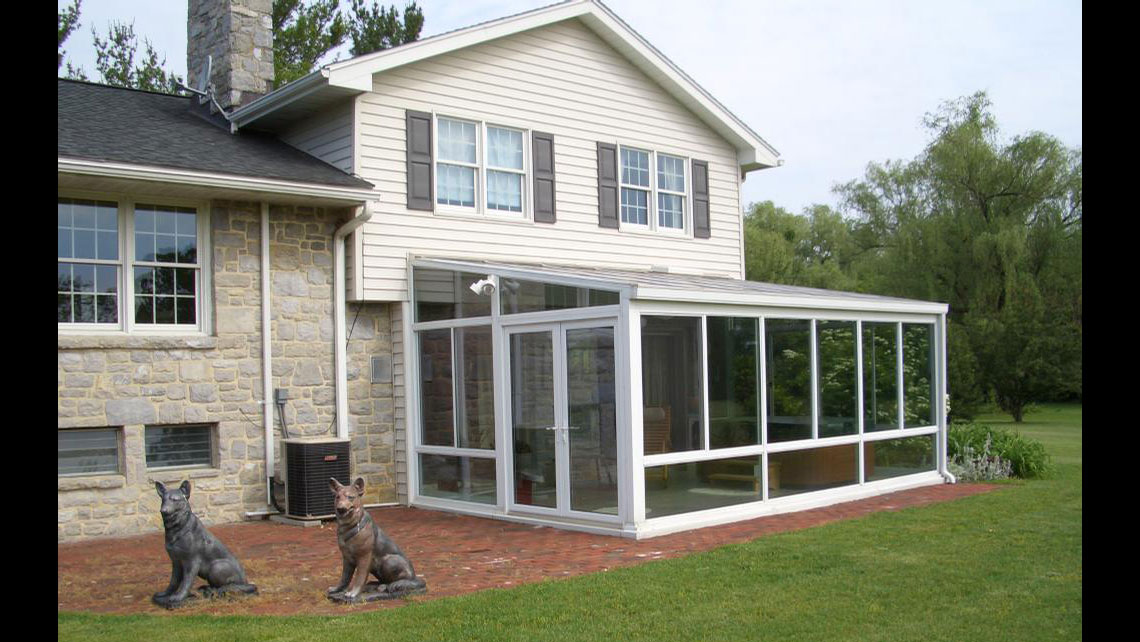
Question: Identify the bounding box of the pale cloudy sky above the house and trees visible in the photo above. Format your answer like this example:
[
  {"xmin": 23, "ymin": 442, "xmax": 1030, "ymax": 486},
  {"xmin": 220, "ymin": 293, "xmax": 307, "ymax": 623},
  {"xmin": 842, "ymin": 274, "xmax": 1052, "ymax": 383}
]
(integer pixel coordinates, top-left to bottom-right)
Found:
[{"xmin": 58, "ymin": 0, "xmax": 1083, "ymax": 213}]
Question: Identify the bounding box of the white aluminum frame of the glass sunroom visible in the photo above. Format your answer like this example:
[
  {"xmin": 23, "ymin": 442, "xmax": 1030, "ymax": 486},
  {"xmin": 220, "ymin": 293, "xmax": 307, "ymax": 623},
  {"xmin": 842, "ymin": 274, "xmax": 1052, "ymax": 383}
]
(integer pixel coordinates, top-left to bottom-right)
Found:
[{"xmin": 405, "ymin": 258, "xmax": 948, "ymax": 538}]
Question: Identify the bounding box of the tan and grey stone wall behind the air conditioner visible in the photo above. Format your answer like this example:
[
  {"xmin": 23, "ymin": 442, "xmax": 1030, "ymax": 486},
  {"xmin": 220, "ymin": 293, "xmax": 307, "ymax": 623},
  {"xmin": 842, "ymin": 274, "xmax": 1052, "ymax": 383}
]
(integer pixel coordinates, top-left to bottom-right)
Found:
[{"xmin": 57, "ymin": 201, "xmax": 396, "ymax": 542}]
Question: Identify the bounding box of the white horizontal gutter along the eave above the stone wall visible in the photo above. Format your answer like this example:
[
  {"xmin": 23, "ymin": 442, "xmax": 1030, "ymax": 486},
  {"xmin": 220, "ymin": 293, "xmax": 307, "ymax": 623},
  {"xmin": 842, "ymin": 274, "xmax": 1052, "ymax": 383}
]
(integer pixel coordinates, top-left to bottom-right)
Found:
[{"xmin": 57, "ymin": 159, "xmax": 376, "ymax": 203}]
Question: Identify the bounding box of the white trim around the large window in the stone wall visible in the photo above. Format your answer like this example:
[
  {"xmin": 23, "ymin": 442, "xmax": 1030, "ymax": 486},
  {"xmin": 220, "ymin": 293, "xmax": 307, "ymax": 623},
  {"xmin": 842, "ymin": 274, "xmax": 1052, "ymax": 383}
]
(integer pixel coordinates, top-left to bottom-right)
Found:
[{"xmin": 56, "ymin": 190, "xmax": 213, "ymax": 336}]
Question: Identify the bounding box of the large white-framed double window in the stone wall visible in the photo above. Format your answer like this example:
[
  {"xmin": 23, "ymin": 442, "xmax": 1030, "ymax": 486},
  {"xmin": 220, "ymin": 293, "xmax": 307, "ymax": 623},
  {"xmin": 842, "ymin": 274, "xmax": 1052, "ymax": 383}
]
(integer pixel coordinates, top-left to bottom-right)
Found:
[{"xmin": 56, "ymin": 196, "xmax": 210, "ymax": 334}]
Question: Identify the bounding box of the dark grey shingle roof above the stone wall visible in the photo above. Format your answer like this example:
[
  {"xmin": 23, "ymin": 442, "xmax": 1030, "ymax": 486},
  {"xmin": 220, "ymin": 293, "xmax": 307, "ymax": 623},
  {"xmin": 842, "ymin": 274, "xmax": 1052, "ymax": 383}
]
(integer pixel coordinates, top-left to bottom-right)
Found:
[{"xmin": 57, "ymin": 79, "xmax": 373, "ymax": 189}]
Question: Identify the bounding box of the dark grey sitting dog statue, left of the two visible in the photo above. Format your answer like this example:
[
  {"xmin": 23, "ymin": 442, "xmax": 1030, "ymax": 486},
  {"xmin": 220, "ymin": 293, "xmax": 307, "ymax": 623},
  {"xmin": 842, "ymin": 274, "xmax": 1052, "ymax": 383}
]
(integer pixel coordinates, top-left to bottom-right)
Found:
[{"xmin": 150, "ymin": 481, "xmax": 258, "ymax": 609}]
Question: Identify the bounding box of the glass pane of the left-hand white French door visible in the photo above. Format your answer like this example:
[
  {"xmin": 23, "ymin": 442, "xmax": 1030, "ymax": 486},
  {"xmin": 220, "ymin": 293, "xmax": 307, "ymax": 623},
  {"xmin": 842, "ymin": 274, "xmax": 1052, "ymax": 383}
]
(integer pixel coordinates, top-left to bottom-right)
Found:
[{"xmin": 511, "ymin": 331, "xmax": 557, "ymax": 509}]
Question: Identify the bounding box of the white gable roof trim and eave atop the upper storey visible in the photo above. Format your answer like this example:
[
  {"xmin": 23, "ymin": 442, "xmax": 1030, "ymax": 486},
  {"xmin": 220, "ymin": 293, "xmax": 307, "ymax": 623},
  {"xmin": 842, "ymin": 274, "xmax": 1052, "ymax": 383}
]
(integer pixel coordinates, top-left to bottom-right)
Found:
[{"xmin": 231, "ymin": 0, "xmax": 780, "ymax": 172}]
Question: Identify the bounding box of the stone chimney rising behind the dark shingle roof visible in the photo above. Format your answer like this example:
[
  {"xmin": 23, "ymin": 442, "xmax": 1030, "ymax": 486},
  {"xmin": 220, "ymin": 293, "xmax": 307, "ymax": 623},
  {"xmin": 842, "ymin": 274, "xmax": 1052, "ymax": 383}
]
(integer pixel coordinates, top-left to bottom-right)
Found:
[{"xmin": 186, "ymin": 0, "xmax": 274, "ymax": 112}]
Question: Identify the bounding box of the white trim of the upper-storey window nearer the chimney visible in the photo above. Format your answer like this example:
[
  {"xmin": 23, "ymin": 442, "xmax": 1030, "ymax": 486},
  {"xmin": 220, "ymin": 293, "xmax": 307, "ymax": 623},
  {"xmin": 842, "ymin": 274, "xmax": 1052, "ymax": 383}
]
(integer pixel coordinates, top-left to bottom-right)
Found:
[{"xmin": 431, "ymin": 112, "xmax": 535, "ymax": 221}]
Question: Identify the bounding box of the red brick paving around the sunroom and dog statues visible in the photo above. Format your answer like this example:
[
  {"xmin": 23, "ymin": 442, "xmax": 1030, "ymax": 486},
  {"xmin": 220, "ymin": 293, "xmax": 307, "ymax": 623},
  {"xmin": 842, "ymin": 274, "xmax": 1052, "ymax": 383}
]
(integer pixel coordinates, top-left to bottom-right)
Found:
[{"xmin": 58, "ymin": 483, "xmax": 1000, "ymax": 615}]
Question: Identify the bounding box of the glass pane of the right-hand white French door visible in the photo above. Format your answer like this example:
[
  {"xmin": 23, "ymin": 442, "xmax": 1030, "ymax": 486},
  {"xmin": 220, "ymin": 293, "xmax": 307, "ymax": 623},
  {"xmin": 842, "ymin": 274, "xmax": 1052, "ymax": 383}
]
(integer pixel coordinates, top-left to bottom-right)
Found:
[{"xmin": 565, "ymin": 327, "xmax": 618, "ymax": 514}]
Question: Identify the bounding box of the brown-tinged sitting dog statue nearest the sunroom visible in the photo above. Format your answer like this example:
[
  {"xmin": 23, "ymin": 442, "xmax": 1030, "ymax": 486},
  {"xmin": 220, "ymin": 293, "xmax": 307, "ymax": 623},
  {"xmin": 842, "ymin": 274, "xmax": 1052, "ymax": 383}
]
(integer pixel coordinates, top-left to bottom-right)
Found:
[{"xmin": 328, "ymin": 477, "xmax": 428, "ymax": 602}]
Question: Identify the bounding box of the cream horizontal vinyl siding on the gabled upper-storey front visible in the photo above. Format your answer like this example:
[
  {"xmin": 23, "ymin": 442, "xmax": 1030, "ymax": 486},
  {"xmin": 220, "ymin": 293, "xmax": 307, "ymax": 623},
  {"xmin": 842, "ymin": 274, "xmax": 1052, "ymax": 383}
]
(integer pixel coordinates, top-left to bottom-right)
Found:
[{"xmin": 357, "ymin": 21, "xmax": 743, "ymax": 301}]
